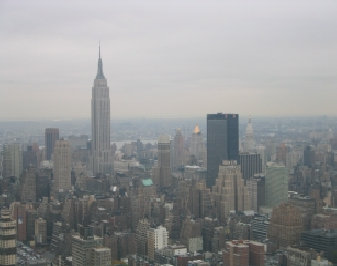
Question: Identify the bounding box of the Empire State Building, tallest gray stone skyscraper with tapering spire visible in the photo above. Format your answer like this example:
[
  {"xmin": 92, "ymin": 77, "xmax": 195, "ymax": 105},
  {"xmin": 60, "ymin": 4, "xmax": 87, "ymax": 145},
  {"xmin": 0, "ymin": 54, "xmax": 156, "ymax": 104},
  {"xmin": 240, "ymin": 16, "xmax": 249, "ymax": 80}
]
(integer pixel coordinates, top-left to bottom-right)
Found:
[{"xmin": 91, "ymin": 48, "xmax": 113, "ymax": 175}]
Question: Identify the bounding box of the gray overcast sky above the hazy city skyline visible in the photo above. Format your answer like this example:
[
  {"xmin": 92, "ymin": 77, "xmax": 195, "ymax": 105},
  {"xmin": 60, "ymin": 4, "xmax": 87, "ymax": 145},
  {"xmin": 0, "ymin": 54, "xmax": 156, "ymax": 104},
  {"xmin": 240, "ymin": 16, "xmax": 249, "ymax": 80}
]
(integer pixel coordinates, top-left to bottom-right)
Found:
[{"xmin": 0, "ymin": 0, "xmax": 337, "ymax": 120}]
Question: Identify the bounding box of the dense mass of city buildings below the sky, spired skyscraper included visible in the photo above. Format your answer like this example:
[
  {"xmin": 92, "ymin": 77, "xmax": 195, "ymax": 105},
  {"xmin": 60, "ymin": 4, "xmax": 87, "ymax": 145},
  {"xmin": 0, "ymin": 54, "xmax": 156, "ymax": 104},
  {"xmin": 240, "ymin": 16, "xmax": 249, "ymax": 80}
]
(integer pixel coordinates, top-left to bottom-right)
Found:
[{"xmin": 0, "ymin": 50, "xmax": 337, "ymax": 266}]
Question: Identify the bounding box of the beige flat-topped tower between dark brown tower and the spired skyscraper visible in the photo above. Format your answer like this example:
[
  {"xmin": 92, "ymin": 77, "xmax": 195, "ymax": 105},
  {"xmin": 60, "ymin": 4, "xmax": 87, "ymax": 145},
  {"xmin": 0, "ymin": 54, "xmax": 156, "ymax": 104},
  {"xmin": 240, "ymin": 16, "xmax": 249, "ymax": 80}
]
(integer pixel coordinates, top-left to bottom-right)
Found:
[{"xmin": 53, "ymin": 140, "xmax": 71, "ymax": 193}]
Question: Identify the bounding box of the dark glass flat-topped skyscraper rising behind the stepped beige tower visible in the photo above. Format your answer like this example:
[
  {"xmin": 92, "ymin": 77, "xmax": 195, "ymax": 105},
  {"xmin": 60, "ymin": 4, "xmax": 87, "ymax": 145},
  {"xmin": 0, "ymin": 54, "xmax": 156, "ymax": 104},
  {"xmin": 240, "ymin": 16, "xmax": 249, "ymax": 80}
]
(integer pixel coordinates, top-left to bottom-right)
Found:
[{"xmin": 207, "ymin": 113, "xmax": 239, "ymax": 187}]
